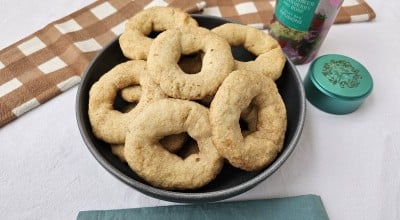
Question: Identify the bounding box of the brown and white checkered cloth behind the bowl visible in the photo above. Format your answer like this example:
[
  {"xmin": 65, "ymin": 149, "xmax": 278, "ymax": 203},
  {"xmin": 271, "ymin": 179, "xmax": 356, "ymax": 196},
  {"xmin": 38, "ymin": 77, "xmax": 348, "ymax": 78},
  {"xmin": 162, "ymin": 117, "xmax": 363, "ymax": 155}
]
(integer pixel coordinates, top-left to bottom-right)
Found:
[{"xmin": 0, "ymin": 0, "xmax": 375, "ymax": 127}]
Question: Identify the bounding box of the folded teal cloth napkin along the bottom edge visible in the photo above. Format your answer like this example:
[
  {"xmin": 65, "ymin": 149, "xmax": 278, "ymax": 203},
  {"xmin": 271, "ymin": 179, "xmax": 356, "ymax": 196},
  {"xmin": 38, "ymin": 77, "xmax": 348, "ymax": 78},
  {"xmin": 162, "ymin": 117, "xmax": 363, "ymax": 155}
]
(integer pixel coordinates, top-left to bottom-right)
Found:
[{"xmin": 77, "ymin": 195, "xmax": 329, "ymax": 220}]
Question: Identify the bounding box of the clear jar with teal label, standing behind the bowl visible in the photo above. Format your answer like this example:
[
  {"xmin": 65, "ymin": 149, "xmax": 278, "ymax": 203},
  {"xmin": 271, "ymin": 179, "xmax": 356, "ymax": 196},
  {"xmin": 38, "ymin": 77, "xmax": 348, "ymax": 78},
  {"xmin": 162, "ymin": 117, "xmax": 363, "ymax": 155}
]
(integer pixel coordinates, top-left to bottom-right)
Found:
[{"xmin": 270, "ymin": 0, "xmax": 343, "ymax": 64}]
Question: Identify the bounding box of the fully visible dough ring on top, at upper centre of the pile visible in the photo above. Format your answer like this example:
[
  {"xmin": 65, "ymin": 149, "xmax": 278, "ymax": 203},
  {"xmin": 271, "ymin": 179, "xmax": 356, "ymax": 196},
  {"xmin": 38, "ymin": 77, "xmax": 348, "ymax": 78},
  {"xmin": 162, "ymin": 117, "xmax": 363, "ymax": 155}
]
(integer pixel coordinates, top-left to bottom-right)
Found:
[{"xmin": 147, "ymin": 27, "xmax": 234, "ymax": 100}]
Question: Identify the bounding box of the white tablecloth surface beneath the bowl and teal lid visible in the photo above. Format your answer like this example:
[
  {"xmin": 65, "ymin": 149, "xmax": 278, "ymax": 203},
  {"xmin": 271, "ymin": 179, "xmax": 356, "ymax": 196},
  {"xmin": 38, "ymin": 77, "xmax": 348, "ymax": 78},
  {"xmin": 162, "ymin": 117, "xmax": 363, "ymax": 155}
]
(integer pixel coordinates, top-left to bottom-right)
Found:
[{"xmin": 0, "ymin": 0, "xmax": 400, "ymax": 220}]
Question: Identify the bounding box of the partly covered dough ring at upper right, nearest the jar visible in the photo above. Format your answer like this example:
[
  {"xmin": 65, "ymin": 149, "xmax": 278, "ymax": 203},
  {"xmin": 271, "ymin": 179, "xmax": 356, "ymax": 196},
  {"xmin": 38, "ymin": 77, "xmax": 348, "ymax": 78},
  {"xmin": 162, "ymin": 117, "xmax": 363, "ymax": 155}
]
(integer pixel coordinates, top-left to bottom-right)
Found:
[{"xmin": 211, "ymin": 23, "xmax": 286, "ymax": 80}]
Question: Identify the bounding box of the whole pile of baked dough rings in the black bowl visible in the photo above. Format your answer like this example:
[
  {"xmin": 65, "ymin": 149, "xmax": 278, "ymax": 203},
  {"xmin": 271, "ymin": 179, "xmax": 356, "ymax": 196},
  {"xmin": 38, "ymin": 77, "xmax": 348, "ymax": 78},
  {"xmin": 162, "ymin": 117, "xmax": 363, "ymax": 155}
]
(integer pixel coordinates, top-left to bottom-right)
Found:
[{"xmin": 88, "ymin": 7, "xmax": 287, "ymax": 190}]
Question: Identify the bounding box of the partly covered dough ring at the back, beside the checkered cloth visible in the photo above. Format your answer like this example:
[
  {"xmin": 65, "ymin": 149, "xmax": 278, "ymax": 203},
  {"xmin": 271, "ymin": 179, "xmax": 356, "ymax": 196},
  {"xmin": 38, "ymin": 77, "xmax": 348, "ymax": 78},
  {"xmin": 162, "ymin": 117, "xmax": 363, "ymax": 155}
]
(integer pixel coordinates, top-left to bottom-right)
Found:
[{"xmin": 119, "ymin": 6, "xmax": 198, "ymax": 60}]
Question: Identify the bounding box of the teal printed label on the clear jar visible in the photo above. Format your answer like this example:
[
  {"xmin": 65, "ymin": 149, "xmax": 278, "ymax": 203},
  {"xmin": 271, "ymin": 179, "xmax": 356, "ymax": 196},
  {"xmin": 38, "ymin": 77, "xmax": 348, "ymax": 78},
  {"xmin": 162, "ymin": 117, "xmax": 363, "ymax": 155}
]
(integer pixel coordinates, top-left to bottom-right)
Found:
[{"xmin": 275, "ymin": 0, "xmax": 319, "ymax": 31}]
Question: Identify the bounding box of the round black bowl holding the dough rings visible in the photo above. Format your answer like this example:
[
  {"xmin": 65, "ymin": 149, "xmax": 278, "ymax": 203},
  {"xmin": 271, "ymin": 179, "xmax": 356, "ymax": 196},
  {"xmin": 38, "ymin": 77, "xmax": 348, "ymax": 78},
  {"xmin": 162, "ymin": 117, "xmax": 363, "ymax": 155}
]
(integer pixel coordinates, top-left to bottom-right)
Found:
[{"xmin": 76, "ymin": 15, "xmax": 305, "ymax": 203}]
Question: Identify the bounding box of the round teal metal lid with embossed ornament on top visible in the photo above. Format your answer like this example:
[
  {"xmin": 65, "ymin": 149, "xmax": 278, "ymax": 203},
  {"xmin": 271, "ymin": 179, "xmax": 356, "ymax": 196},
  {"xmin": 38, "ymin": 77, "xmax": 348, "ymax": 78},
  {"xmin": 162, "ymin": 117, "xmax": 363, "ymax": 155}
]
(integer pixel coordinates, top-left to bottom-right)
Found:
[{"xmin": 304, "ymin": 54, "xmax": 373, "ymax": 114}]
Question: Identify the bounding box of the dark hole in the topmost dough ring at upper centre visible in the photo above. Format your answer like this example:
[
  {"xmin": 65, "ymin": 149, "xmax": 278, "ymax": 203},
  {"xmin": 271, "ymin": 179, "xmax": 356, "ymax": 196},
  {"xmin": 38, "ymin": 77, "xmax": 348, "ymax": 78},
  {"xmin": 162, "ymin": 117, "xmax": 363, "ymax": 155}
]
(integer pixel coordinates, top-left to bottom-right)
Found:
[{"xmin": 178, "ymin": 51, "xmax": 204, "ymax": 74}]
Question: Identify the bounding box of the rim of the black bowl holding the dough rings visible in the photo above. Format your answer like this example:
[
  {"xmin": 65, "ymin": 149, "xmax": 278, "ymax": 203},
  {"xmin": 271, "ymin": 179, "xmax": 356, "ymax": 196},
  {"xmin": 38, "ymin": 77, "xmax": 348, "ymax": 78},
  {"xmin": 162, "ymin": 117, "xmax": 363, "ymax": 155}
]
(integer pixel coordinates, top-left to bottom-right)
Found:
[{"xmin": 75, "ymin": 14, "xmax": 306, "ymax": 203}]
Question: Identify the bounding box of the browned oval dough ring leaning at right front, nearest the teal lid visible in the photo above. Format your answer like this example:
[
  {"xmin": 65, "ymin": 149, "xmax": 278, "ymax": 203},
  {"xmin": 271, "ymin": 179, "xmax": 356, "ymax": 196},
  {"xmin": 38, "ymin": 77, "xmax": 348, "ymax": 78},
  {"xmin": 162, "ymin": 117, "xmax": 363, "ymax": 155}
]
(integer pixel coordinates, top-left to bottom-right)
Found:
[{"xmin": 210, "ymin": 70, "xmax": 287, "ymax": 171}]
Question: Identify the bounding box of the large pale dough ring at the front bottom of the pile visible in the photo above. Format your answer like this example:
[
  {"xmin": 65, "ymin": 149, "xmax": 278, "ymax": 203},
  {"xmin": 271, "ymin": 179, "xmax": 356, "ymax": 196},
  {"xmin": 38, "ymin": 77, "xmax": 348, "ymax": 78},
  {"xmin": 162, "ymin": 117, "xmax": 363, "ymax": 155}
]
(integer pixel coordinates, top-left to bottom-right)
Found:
[{"xmin": 124, "ymin": 99, "xmax": 223, "ymax": 190}]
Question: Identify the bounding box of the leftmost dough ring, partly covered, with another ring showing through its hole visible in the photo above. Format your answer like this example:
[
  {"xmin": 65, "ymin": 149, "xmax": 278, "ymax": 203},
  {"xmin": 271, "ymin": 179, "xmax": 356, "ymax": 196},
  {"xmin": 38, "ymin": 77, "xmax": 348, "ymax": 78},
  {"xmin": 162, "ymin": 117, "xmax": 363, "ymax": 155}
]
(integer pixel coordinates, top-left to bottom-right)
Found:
[{"xmin": 88, "ymin": 60, "xmax": 166, "ymax": 144}]
